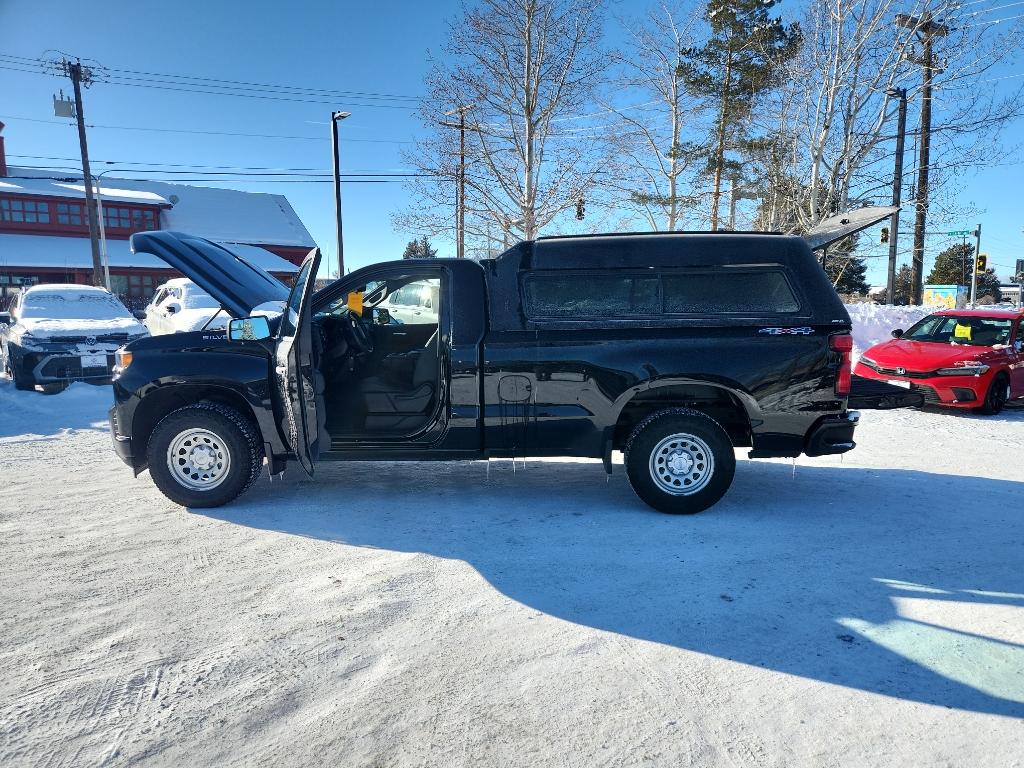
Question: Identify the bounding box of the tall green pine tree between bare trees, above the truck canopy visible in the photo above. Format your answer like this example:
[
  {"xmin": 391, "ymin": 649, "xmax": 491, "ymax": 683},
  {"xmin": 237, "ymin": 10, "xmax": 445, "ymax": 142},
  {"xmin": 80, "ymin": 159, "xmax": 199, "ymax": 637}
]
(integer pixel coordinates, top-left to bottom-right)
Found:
[{"xmin": 680, "ymin": 0, "xmax": 801, "ymax": 230}]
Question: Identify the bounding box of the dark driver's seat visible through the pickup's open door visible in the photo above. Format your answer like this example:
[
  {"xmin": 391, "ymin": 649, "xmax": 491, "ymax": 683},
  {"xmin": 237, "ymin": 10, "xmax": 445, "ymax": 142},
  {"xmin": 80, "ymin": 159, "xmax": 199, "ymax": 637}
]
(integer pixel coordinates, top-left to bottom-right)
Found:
[{"xmin": 359, "ymin": 331, "xmax": 440, "ymax": 429}]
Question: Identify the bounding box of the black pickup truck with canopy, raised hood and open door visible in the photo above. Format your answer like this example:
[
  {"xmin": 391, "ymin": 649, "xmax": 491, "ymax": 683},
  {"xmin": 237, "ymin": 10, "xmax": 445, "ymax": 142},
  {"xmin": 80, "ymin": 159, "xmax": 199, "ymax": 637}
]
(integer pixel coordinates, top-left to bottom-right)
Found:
[{"xmin": 110, "ymin": 231, "xmax": 858, "ymax": 513}]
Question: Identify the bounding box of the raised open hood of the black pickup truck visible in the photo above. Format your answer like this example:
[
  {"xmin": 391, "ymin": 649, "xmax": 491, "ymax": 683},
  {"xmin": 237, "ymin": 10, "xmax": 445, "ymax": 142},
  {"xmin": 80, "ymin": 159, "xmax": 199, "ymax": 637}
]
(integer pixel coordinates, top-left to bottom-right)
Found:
[{"xmin": 131, "ymin": 231, "xmax": 288, "ymax": 317}]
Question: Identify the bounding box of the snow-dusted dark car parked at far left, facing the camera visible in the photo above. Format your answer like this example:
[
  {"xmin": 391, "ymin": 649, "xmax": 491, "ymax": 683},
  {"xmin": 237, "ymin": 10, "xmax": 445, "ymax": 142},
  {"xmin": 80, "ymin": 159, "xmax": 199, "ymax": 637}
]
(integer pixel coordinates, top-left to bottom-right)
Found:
[{"xmin": 0, "ymin": 284, "xmax": 148, "ymax": 389}]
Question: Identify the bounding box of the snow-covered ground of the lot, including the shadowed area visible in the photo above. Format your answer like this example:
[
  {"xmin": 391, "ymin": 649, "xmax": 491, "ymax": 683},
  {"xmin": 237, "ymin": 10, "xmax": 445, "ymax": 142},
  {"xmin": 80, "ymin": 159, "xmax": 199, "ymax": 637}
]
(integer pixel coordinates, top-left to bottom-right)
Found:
[{"xmin": 0, "ymin": 379, "xmax": 1024, "ymax": 768}]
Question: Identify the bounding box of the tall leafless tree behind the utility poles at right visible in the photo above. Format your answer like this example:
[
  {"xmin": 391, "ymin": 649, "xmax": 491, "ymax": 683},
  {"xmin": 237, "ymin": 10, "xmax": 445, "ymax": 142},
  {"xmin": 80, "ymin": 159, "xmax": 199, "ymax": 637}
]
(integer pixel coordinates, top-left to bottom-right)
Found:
[{"xmin": 759, "ymin": 0, "xmax": 1022, "ymax": 229}]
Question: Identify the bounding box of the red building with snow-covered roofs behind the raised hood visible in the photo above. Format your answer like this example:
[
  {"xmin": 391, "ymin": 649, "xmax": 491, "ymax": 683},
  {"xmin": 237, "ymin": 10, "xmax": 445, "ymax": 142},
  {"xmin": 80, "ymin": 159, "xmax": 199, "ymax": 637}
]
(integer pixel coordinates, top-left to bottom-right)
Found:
[{"xmin": 0, "ymin": 123, "xmax": 315, "ymax": 307}]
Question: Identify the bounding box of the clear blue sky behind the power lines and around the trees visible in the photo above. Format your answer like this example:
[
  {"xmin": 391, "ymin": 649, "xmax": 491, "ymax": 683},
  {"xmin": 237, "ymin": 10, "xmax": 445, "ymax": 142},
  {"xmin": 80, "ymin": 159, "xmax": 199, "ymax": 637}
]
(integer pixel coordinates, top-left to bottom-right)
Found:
[{"xmin": 0, "ymin": 0, "xmax": 1024, "ymax": 283}]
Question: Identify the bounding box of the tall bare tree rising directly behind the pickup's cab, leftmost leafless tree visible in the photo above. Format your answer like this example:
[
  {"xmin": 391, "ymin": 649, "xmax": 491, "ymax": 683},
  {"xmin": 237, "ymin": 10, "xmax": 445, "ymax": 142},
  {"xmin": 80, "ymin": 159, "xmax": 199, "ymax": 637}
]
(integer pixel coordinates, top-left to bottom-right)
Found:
[{"xmin": 395, "ymin": 0, "xmax": 606, "ymax": 249}]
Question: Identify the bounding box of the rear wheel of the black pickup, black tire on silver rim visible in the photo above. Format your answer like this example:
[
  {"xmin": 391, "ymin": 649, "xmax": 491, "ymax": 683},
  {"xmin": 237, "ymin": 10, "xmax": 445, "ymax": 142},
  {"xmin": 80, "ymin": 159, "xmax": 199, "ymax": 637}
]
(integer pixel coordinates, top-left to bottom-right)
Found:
[{"xmin": 625, "ymin": 408, "xmax": 736, "ymax": 515}]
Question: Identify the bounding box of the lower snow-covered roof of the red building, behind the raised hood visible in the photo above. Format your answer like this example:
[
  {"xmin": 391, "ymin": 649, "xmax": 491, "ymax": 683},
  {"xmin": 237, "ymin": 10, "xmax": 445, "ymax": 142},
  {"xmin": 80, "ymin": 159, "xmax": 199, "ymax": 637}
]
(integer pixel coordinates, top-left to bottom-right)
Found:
[{"xmin": 0, "ymin": 234, "xmax": 299, "ymax": 273}]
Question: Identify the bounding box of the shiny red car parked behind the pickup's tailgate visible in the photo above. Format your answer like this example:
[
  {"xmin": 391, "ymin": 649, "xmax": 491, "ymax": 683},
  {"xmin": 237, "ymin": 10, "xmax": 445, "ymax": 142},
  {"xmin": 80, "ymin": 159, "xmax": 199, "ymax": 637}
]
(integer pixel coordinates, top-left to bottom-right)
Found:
[{"xmin": 854, "ymin": 309, "xmax": 1024, "ymax": 414}]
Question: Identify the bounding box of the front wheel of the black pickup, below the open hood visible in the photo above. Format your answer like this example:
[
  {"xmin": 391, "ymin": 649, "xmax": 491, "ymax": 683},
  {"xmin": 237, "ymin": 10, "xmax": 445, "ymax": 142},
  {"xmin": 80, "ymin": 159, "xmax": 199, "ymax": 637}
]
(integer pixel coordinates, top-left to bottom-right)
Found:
[{"xmin": 146, "ymin": 401, "xmax": 263, "ymax": 508}]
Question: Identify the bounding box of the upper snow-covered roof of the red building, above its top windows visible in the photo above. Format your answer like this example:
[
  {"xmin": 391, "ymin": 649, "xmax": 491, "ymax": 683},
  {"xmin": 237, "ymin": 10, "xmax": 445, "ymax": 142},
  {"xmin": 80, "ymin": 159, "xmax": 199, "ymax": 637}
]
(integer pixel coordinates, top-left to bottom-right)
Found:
[{"xmin": 6, "ymin": 168, "xmax": 316, "ymax": 248}]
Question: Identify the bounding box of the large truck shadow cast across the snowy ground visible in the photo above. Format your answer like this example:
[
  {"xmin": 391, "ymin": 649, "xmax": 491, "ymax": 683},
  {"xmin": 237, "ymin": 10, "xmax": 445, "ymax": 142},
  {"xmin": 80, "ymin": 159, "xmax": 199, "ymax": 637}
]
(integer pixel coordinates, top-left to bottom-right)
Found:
[{"xmin": 197, "ymin": 461, "xmax": 1024, "ymax": 717}]
